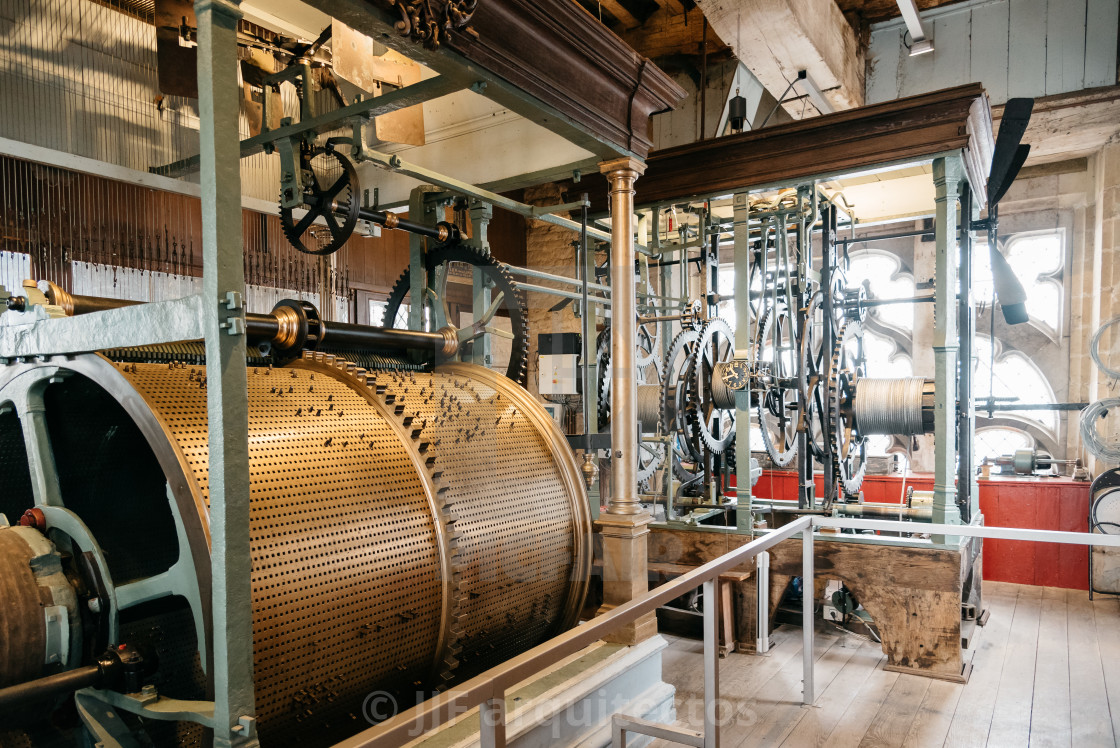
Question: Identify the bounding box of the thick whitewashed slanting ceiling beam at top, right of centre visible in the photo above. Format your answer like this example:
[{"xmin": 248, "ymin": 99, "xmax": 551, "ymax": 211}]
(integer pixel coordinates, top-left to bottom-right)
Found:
[{"xmin": 697, "ymin": 0, "xmax": 864, "ymax": 118}]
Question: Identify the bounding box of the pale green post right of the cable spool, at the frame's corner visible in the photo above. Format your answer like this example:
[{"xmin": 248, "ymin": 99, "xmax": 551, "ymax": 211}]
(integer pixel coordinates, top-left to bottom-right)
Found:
[{"xmin": 933, "ymin": 157, "xmax": 963, "ymax": 543}]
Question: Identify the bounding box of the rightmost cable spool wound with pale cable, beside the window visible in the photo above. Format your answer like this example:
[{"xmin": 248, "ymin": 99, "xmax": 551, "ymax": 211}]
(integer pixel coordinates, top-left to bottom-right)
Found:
[{"xmin": 855, "ymin": 376, "xmax": 934, "ymax": 437}]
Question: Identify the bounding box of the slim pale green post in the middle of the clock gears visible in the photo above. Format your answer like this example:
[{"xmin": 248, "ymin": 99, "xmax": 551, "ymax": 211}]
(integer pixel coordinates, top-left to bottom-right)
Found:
[{"xmin": 731, "ymin": 193, "xmax": 755, "ymax": 532}]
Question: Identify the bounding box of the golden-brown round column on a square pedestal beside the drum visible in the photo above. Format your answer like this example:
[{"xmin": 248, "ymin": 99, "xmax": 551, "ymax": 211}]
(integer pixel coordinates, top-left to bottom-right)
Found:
[{"xmin": 596, "ymin": 158, "xmax": 657, "ymax": 644}]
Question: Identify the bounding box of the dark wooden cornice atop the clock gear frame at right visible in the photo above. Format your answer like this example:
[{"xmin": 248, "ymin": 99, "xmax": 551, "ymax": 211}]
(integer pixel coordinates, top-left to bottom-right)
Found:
[{"xmin": 581, "ymin": 83, "xmax": 993, "ymax": 212}]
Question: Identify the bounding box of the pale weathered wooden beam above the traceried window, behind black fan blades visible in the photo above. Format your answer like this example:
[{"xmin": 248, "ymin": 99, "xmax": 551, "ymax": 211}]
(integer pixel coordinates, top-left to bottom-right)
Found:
[{"xmin": 991, "ymin": 85, "xmax": 1120, "ymax": 165}]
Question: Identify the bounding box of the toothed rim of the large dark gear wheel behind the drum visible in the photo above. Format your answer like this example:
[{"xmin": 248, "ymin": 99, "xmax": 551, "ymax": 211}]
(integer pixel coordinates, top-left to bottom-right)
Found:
[{"xmin": 384, "ymin": 244, "xmax": 529, "ymax": 386}]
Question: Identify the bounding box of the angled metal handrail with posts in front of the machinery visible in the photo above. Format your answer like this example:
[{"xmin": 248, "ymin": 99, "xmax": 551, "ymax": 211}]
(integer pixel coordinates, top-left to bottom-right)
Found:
[{"xmin": 335, "ymin": 515, "xmax": 1120, "ymax": 748}]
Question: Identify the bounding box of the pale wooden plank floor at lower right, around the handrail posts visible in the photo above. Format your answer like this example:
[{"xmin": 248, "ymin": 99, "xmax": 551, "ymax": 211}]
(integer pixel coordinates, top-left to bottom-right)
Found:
[{"xmin": 653, "ymin": 582, "xmax": 1120, "ymax": 748}]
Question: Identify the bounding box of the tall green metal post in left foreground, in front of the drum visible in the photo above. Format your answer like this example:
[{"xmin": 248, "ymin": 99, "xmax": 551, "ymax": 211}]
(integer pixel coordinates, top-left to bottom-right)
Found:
[{"xmin": 195, "ymin": 0, "xmax": 256, "ymax": 748}]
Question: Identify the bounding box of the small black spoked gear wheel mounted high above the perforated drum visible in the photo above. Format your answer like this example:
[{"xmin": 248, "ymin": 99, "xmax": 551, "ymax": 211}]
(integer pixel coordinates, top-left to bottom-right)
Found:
[{"xmin": 280, "ymin": 148, "xmax": 361, "ymax": 255}]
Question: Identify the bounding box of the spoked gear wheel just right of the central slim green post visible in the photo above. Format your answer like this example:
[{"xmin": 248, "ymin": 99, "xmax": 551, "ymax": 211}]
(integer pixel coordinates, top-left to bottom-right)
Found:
[{"xmin": 755, "ymin": 301, "xmax": 800, "ymax": 467}]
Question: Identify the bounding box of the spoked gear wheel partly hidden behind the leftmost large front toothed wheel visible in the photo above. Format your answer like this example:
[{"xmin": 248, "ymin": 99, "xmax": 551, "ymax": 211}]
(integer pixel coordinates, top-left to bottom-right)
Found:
[{"xmin": 661, "ymin": 329, "xmax": 703, "ymax": 481}]
